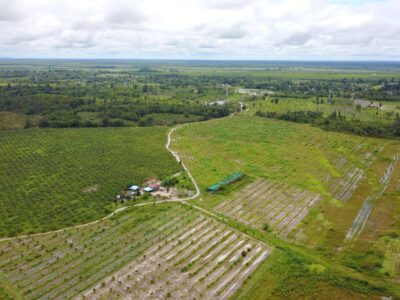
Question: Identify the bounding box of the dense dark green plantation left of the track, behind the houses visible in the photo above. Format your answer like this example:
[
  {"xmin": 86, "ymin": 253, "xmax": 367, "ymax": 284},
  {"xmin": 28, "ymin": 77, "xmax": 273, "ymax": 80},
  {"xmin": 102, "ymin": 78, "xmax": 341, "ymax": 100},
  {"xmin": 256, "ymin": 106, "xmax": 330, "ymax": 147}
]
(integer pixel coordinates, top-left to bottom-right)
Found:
[{"xmin": 0, "ymin": 127, "xmax": 180, "ymax": 236}]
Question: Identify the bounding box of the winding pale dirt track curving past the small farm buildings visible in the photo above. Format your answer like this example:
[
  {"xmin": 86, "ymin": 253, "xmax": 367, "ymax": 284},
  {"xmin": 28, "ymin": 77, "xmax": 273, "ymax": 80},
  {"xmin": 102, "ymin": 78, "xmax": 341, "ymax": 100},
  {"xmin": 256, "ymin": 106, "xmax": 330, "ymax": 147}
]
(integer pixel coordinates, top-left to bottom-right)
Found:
[{"xmin": 0, "ymin": 125, "xmax": 200, "ymax": 242}]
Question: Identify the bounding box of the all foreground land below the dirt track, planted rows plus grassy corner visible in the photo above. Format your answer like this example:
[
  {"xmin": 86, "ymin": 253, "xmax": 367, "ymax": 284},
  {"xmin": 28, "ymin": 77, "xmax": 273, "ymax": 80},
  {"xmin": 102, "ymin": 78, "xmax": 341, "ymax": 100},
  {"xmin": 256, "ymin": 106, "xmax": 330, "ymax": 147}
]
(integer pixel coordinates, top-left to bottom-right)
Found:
[{"xmin": 0, "ymin": 204, "xmax": 394, "ymax": 299}]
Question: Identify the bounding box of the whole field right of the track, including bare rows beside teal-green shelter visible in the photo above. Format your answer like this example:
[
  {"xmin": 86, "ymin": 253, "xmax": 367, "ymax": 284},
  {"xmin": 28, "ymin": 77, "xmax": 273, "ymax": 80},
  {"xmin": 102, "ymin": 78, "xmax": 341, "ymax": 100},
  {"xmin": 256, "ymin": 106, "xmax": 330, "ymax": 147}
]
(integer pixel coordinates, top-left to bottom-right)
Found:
[{"xmin": 173, "ymin": 115, "xmax": 400, "ymax": 276}]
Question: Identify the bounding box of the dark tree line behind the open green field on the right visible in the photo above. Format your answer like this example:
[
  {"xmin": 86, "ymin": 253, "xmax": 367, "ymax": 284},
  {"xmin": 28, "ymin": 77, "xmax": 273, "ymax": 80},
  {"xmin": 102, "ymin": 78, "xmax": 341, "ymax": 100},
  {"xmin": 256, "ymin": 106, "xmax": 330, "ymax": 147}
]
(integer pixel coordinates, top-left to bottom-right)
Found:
[{"xmin": 255, "ymin": 110, "xmax": 400, "ymax": 138}]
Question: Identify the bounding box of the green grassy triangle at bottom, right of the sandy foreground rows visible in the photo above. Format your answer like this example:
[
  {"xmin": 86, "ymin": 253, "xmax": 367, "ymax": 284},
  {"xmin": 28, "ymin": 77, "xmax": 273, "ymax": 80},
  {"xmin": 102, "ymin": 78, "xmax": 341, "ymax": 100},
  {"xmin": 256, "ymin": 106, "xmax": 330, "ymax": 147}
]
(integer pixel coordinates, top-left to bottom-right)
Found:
[{"xmin": 232, "ymin": 251, "xmax": 381, "ymax": 300}]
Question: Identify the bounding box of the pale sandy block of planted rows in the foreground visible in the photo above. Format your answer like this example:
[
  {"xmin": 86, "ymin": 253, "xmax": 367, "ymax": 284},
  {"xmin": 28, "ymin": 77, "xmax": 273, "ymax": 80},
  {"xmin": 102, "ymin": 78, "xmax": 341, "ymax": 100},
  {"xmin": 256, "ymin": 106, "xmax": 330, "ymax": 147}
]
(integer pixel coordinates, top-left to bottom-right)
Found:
[{"xmin": 77, "ymin": 217, "xmax": 272, "ymax": 299}]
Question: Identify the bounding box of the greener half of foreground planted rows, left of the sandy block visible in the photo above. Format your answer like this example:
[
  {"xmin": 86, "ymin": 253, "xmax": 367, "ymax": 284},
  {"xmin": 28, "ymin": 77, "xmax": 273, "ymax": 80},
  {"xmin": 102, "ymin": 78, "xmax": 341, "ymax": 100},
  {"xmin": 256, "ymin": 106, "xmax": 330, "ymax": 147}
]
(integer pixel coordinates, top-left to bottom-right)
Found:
[{"xmin": 0, "ymin": 204, "xmax": 197, "ymax": 299}]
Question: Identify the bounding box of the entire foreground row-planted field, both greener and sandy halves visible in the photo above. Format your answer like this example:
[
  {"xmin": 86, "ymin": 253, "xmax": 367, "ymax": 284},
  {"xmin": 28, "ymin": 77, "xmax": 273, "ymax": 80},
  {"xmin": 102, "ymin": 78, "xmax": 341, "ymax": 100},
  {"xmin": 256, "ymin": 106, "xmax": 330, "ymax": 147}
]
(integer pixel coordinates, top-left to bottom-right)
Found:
[{"xmin": 0, "ymin": 204, "xmax": 272, "ymax": 299}]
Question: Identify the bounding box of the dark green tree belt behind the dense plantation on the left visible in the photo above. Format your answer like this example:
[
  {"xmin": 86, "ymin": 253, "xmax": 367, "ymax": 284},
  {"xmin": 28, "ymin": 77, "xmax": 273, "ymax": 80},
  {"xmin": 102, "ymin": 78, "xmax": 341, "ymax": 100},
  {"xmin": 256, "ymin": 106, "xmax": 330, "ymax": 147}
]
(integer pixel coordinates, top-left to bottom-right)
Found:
[{"xmin": 0, "ymin": 86, "xmax": 234, "ymax": 128}]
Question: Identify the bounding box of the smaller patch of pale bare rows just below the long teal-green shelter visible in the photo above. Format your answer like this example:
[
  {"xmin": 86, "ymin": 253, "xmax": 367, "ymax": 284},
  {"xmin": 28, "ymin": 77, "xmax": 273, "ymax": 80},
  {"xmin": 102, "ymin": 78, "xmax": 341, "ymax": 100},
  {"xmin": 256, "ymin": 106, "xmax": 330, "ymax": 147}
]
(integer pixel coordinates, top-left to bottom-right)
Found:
[{"xmin": 215, "ymin": 179, "xmax": 321, "ymax": 237}]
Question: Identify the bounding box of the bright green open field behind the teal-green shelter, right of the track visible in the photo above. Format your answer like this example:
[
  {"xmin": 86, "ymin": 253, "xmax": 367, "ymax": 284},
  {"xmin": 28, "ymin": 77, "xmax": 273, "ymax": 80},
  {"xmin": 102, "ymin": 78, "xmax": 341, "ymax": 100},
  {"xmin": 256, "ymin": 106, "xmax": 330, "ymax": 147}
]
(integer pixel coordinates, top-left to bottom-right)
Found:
[{"xmin": 172, "ymin": 115, "xmax": 386, "ymax": 198}]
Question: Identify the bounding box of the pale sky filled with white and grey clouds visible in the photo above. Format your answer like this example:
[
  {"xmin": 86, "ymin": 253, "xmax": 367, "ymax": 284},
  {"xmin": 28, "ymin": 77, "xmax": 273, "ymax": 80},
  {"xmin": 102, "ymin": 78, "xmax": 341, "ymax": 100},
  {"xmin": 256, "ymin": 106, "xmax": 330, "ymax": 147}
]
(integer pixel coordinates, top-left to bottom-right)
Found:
[{"xmin": 0, "ymin": 0, "xmax": 400, "ymax": 60}]
